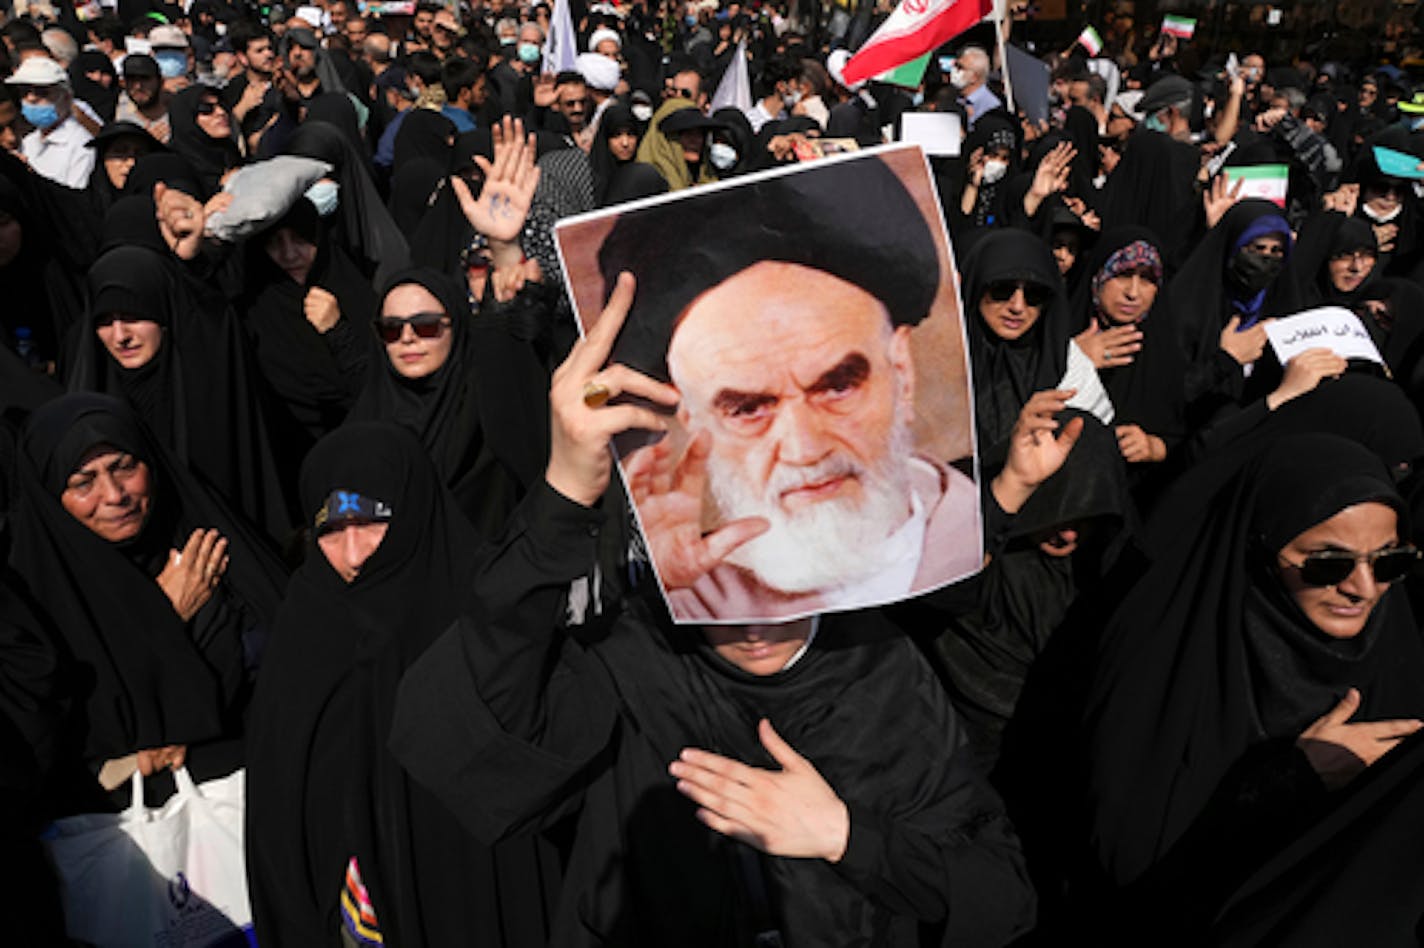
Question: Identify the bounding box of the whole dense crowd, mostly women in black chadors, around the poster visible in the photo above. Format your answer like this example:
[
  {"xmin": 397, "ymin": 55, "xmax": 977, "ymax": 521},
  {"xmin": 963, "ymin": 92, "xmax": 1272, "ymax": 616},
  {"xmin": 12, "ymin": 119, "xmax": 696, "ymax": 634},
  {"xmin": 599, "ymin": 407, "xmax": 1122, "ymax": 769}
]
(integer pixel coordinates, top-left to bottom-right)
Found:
[{"xmin": 0, "ymin": 0, "xmax": 1424, "ymax": 948}]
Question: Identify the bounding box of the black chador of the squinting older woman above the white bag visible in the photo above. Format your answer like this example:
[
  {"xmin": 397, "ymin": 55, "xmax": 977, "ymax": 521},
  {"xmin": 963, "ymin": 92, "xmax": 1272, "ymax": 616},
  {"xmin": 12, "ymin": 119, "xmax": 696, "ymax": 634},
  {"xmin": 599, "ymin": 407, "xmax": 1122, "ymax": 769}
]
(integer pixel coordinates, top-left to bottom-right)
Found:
[{"xmin": 10, "ymin": 393, "xmax": 286, "ymax": 770}]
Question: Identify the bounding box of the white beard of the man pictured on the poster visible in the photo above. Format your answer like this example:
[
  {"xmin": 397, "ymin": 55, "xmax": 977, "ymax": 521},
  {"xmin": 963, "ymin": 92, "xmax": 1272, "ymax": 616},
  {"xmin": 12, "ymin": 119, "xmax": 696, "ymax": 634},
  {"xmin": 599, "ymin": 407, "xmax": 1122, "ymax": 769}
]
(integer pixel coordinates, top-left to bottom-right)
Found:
[{"xmin": 708, "ymin": 407, "xmax": 913, "ymax": 594}]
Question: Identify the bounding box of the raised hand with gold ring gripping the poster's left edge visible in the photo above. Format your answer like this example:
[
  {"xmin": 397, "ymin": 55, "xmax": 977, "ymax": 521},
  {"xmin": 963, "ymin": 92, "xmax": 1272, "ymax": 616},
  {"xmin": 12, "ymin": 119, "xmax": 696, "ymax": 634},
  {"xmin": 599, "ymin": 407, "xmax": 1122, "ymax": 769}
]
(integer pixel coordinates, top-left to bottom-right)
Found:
[{"xmin": 544, "ymin": 273, "xmax": 678, "ymax": 507}]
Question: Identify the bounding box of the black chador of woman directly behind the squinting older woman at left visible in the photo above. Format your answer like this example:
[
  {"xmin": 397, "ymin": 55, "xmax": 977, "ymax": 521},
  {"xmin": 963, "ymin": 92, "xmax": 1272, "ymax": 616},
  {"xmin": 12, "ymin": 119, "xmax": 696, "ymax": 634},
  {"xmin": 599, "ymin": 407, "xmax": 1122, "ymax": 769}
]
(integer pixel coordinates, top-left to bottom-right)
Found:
[{"xmin": 66, "ymin": 243, "xmax": 292, "ymax": 538}]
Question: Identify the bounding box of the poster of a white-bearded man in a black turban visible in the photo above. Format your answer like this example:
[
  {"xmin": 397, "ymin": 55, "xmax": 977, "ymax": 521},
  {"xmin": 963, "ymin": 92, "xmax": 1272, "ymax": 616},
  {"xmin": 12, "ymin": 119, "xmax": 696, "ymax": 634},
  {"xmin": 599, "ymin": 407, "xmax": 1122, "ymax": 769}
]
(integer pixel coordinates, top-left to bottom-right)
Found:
[{"xmin": 558, "ymin": 149, "xmax": 983, "ymax": 622}]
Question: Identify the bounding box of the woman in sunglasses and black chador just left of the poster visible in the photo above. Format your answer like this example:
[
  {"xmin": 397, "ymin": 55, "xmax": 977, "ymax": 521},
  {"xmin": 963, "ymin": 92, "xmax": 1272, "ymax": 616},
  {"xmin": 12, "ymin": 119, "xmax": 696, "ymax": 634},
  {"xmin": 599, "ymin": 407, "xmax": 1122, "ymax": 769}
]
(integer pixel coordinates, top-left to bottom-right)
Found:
[{"xmin": 347, "ymin": 268, "xmax": 548, "ymax": 537}]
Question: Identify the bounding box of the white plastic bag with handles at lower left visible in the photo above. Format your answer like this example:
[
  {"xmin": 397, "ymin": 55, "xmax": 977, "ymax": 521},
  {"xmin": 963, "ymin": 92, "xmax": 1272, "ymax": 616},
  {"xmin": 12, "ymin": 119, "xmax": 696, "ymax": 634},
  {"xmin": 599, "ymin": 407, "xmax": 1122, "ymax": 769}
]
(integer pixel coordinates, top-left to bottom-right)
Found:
[{"xmin": 46, "ymin": 767, "xmax": 252, "ymax": 948}]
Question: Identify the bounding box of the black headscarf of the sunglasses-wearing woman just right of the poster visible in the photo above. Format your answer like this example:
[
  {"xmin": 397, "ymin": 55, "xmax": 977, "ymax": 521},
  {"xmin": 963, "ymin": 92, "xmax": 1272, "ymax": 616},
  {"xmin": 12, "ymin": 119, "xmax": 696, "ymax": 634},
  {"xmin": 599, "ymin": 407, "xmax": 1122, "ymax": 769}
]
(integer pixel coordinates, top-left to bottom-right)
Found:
[{"xmin": 963, "ymin": 228, "xmax": 1072, "ymax": 467}]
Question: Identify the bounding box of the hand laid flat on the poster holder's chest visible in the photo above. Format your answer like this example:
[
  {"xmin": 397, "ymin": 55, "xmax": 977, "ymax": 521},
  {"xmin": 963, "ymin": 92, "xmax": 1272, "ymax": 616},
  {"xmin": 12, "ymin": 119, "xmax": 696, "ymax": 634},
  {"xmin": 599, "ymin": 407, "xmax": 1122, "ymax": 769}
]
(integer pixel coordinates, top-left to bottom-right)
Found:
[{"xmin": 668, "ymin": 717, "xmax": 850, "ymax": 863}]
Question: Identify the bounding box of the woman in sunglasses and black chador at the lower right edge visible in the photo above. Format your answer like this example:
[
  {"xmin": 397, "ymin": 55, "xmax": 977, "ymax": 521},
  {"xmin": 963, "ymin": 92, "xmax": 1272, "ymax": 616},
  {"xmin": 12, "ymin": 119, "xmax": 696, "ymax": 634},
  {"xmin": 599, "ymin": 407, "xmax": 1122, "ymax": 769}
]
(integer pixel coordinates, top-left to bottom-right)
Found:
[{"xmin": 1088, "ymin": 434, "xmax": 1424, "ymax": 944}]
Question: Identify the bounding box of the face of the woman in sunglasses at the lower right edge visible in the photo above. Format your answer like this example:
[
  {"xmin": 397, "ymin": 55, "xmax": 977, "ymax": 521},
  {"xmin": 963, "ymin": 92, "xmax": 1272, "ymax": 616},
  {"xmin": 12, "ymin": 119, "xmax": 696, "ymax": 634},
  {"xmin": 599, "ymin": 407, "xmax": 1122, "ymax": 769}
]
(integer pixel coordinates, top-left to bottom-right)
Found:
[{"xmin": 1276, "ymin": 501, "xmax": 1400, "ymax": 639}]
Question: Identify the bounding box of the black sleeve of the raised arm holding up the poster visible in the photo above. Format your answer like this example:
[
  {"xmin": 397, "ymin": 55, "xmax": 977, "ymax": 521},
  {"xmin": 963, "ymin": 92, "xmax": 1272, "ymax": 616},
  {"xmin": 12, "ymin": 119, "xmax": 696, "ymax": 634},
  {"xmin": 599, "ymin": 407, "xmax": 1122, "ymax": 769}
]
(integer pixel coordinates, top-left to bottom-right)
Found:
[{"xmin": 390, "ymin": 484, "xmax": 617, "ymax": 843}]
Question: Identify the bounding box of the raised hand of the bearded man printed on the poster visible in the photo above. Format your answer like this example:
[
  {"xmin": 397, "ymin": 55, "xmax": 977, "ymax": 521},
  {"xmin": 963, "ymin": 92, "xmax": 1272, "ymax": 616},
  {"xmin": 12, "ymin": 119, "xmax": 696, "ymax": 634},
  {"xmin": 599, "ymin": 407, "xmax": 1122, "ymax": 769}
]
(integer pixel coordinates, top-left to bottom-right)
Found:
[{"xmin": 625, "ymin": 431, "xmax": 770, "ymax": 589}]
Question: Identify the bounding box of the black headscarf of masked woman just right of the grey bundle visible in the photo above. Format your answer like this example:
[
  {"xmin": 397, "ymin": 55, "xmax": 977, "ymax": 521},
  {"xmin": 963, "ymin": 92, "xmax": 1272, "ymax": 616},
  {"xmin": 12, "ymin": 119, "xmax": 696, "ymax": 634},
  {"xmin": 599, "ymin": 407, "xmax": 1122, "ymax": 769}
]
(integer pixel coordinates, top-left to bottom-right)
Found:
[{"xmin": 286, "ymin": 121, "xmax": 410, "ymax": 285}]
